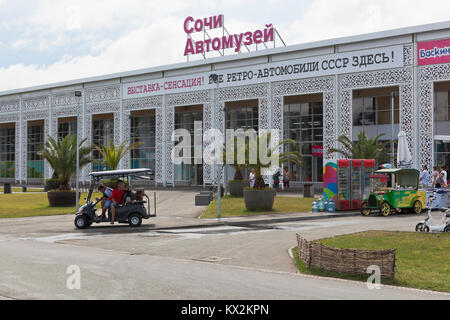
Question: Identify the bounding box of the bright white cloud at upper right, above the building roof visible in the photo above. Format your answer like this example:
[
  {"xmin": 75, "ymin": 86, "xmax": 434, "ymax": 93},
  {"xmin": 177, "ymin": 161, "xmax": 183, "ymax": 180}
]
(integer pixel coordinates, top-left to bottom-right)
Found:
[{"xmin": 278, "ymin": 0, "xmax": 450, "ymax": 45}]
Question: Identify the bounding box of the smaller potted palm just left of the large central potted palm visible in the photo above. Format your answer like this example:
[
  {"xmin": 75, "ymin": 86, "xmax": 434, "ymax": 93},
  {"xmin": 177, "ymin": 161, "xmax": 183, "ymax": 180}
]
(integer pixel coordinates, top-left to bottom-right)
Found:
[{"xmin": 223, "ymin": 137, "xmax": 250, "ymax": 197}]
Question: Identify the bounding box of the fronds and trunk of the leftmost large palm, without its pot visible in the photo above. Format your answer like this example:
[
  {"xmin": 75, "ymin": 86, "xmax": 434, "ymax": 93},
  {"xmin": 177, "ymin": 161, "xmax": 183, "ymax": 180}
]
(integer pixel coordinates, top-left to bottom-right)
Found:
[{"xmin": 39, "ymin": 135, "xmax": 92, "ymax": 191}]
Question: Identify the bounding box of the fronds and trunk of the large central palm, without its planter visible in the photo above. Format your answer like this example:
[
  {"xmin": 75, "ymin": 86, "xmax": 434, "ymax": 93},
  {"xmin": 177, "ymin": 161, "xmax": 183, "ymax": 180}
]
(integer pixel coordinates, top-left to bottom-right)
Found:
[{"xmin": 246, "ymin": 133, "xmax": 303, "ymax": 189}]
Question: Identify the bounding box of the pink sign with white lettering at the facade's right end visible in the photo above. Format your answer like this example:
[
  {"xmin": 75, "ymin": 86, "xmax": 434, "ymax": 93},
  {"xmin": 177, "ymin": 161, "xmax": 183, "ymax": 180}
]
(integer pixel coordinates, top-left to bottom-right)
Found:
[{"xmin": 418, "ymin": 39, "xmax": 450, "ymax": 66}]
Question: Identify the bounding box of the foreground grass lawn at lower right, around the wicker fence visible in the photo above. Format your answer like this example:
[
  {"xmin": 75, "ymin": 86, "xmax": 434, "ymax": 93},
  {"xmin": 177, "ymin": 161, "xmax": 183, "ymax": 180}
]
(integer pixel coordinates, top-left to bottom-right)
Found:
[{"xmin": 293, "ymin": 231, "xmax": 450, "ymax": 292}]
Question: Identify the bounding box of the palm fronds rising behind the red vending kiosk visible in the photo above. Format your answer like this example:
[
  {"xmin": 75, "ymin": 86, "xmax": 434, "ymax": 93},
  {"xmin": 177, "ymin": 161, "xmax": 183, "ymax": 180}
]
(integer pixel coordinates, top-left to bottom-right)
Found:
[{"xmin": 328, "ymin": 131, "xmax": 391, "ymax": 163}]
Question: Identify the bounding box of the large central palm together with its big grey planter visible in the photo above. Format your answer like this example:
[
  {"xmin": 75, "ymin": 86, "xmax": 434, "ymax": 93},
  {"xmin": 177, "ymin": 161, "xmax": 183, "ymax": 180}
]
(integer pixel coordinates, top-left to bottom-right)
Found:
[{"xmin": 244, "ymin": 133, "xmax": 303, "ymax": 211}]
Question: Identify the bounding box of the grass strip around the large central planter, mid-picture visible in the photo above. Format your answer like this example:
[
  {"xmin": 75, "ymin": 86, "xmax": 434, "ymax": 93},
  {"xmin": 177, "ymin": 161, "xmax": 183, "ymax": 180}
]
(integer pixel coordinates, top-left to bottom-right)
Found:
[{"xmin": 200, "ymin": 196, "xmax": 315, "ymax": 219}]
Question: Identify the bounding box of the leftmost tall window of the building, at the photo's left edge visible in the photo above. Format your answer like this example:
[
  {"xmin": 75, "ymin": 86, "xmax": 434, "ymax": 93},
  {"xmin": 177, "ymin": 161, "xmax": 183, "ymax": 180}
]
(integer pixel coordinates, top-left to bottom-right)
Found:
[{"xmin": 0, "ymin": 127, "xmax": 16, "ymax": 179}]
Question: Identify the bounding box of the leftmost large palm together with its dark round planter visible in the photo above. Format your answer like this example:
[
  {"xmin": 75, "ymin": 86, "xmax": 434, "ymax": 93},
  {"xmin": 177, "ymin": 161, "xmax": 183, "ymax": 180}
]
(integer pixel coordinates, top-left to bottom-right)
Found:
[{"xmin": 39, "ymin": 135, "xmax": 92, "ymax": 207}]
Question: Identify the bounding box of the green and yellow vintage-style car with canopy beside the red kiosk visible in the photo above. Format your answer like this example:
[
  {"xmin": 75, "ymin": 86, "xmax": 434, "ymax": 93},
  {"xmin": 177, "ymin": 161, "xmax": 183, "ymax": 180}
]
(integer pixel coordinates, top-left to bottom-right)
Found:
[{"xmin": 361, "ymin": 169, "xmax": 427, "ymax": 217}]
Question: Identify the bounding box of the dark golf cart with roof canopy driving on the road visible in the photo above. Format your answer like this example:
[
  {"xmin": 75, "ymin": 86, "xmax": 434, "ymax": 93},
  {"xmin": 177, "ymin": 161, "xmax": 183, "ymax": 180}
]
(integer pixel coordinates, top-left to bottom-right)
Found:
[{"xmin": 75, "ymin": 169, "xmax": 154, "ymax": 229}]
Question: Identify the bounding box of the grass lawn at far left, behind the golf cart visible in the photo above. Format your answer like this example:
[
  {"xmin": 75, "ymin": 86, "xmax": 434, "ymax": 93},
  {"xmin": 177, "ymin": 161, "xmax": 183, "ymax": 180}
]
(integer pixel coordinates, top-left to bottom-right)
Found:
[{"xmin": 0, "ymin": 193, "xmax": 102, "ymax": 219}]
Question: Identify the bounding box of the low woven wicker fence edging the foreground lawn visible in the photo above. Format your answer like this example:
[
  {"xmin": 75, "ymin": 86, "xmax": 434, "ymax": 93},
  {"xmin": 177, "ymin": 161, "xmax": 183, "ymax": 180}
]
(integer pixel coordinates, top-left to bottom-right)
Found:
[{"xmin": 297, "ymin": 234, "xmax": 397, "ymax": 278}]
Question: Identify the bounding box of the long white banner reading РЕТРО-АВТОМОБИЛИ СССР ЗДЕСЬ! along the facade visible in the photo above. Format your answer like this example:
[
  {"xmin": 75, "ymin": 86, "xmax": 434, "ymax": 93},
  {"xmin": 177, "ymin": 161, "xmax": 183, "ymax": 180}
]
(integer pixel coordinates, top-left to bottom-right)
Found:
[{"xmin": 123, "ymin": 46, "xmax": 404, "ymax": 99}]
